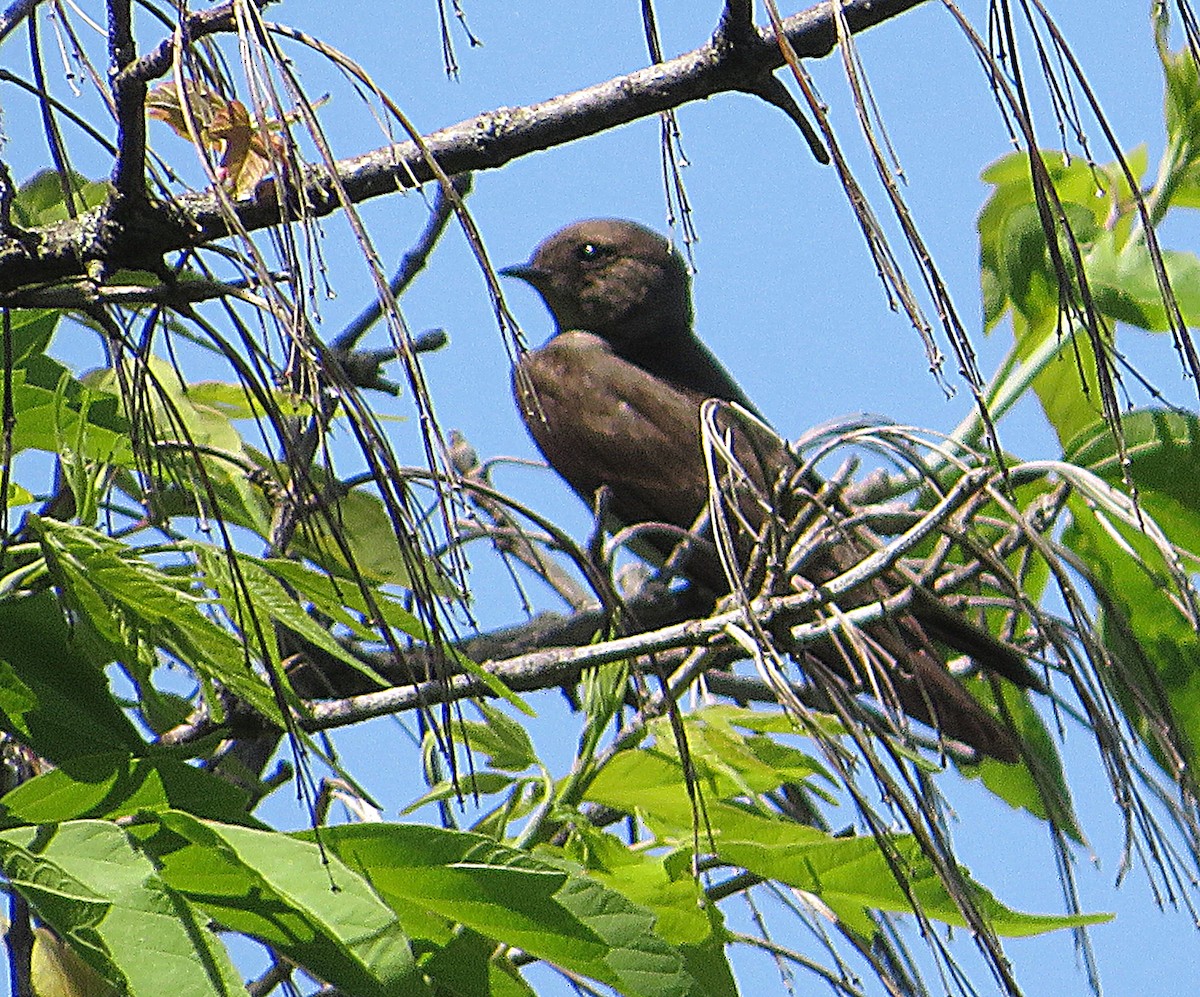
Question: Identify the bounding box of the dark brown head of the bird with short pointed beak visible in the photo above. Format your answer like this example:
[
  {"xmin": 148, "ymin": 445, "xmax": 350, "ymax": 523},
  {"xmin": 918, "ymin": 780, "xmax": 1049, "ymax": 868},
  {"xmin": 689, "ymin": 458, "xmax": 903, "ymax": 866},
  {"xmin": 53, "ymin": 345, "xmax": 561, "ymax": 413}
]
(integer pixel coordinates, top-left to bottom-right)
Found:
[{"xmin": 500, "ymin": 218, "xmax": 691, "ymax": 354}]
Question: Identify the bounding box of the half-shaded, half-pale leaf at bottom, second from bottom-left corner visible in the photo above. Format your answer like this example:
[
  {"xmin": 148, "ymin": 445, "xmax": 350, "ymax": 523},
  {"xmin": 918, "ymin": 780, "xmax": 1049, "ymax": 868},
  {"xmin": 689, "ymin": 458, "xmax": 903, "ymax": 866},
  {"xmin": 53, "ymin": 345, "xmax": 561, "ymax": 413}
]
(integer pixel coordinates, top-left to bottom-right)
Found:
[{"xmin": 151, "ymin": 812, "xmax": 430, "ymax": 997}]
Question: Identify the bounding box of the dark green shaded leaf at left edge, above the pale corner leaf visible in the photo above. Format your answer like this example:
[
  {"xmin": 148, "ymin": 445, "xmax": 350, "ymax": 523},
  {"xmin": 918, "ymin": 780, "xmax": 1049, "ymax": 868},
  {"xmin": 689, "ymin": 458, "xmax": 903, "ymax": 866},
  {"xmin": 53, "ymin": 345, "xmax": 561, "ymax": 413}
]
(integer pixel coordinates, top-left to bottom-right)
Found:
[{"xmin": 0, "ymin": 593, "xmax": 146, "ymax": 764}]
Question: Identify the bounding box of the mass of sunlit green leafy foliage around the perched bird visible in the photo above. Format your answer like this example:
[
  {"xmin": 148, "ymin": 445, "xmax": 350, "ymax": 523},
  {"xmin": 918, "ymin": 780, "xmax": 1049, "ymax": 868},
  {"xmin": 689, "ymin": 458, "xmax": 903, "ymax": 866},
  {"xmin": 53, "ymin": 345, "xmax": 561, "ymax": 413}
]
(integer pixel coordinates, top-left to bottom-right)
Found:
[{"xmin": 0, "ymin": 5, "xmax": 1200, "ymax": 997}]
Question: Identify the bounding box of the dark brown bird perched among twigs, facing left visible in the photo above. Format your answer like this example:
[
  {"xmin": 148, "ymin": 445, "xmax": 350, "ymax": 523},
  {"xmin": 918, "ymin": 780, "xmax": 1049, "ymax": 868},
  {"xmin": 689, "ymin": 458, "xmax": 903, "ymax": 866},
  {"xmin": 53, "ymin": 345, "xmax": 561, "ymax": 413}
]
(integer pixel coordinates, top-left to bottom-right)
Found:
[{"xmin": 500, "ymin": 218, "xmax": 1042, "ymax": 762}]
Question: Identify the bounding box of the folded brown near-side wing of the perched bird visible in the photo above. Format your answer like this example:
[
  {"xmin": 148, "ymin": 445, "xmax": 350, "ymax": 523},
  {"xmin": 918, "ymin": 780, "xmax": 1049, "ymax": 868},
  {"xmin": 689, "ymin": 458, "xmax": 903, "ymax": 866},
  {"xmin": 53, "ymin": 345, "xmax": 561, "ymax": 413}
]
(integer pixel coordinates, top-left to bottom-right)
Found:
[{"xmin": 514, "ymin": 332, "xmax": 1020, "ymax": 762}]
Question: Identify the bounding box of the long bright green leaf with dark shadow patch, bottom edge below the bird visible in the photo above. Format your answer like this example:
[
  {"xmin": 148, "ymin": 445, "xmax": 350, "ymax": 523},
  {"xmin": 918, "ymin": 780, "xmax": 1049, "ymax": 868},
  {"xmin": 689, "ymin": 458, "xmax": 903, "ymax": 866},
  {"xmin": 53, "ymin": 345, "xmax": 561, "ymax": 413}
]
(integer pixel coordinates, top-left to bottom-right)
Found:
[{"xmin": 305, "ymin": 824, "xmax": 692, "ymax": 997}]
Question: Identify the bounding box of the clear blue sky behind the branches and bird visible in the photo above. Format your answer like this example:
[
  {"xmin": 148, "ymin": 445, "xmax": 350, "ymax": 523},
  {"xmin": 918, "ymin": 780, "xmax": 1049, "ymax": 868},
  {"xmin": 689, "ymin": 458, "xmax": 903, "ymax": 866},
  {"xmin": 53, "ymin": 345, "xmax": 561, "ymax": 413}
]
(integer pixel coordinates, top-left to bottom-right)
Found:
[{"xmin": 2, "ymin": 0, "xmax": 1200, "ymax": 997}]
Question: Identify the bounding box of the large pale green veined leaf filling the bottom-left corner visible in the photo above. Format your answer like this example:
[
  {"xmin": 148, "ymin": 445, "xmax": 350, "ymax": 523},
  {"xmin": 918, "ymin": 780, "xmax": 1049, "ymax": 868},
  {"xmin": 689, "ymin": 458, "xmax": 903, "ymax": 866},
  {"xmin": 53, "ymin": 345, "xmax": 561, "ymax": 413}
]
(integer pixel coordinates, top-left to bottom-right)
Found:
[{"xmin": 0, "ymin": 821, "xmax": 245, "ymax": 997}]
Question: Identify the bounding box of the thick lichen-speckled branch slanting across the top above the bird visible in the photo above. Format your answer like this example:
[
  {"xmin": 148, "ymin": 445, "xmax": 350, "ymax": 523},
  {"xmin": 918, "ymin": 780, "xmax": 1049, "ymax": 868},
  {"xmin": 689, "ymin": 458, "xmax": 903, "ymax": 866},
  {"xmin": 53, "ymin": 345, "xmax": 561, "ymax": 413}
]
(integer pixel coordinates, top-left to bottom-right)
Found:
[{"xmin": 0, "ymin": 0, "xmax": 924, "ymax": 292}]
